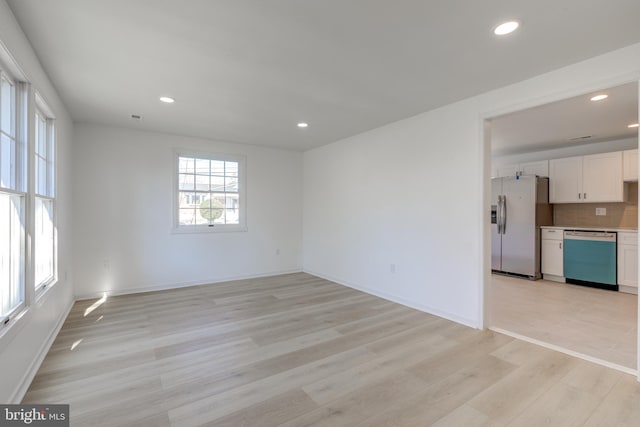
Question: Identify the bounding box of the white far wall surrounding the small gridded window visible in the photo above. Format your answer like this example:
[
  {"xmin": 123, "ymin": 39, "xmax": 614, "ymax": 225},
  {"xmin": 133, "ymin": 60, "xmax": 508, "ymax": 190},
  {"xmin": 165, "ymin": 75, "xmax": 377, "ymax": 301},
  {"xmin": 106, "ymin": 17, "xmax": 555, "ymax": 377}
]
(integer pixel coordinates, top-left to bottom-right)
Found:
[{"xmin": 73, "ymin": 124, "xmax": 302, "ymax": 298}]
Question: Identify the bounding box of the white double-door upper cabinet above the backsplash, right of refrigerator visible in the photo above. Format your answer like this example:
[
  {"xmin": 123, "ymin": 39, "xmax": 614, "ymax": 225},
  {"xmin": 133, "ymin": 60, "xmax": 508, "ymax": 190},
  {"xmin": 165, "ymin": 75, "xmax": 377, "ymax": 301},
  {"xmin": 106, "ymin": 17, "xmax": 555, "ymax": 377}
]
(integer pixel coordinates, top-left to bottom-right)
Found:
[{"xmin": 549, "ymin": 151, "xmax": 624, "ymax": 203}]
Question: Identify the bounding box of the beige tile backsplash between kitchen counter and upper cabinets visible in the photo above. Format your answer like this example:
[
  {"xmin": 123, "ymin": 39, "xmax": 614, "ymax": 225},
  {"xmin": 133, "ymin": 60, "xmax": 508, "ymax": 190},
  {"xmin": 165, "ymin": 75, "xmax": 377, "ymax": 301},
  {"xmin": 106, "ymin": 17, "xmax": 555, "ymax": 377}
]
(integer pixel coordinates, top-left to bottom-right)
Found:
[{"xmin": 553, "ymin": 182, "xmax": 638, "ymax": 229}]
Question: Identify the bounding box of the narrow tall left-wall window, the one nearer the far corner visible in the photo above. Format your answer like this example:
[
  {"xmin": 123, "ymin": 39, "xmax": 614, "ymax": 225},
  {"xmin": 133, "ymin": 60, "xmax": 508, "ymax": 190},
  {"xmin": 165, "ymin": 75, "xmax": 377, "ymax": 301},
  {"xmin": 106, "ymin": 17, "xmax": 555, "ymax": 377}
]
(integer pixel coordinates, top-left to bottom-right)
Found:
[{"xmin": 33, "ymin": 108, "xmax": 56, "ymax": 290}]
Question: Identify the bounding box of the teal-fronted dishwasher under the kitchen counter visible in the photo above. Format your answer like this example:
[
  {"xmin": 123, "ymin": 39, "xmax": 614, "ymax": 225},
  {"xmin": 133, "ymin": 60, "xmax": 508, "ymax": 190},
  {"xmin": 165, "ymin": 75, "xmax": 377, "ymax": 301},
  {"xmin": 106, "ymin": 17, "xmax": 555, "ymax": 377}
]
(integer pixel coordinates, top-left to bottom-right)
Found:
[{"xmin": 564, "ymin": 230, "xmax": 618, "ymax": 291}]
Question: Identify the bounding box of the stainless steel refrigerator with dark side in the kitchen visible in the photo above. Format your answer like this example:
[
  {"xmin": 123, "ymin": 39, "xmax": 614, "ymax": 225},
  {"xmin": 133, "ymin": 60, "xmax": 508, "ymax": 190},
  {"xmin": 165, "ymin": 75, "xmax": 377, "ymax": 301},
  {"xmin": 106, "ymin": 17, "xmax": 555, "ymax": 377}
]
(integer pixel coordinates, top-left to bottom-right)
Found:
[{"xmin": 491, "ymin": 176, "xmax": 553, "ymax": 280}]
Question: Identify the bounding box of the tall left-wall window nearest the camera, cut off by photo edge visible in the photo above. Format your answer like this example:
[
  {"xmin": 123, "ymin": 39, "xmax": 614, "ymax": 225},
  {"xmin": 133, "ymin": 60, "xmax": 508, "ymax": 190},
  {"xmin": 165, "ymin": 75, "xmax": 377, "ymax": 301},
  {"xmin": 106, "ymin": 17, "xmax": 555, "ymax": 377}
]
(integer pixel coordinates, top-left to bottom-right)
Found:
[{"xmin": 0, "ymin": 70, "xmax": 26, "ymax": 326}]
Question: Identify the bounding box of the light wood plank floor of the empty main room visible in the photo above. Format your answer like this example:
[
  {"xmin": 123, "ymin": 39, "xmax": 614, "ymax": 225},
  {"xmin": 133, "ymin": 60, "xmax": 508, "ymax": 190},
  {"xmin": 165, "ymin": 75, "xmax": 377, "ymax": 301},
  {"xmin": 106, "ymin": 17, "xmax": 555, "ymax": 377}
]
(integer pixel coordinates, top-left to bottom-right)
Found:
[{"xmin": 24, "ymin": 273, "xmax": 640, "ymax": 427}]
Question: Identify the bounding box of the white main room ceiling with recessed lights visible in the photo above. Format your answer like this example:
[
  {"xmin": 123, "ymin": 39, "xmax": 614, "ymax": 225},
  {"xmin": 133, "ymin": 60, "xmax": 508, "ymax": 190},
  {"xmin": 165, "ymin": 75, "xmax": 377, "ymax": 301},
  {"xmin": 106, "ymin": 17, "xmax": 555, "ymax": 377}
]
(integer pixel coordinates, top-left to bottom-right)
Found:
[{"xmin": 7, "ymin": 0, "xmax": 640, "ymax": 150}]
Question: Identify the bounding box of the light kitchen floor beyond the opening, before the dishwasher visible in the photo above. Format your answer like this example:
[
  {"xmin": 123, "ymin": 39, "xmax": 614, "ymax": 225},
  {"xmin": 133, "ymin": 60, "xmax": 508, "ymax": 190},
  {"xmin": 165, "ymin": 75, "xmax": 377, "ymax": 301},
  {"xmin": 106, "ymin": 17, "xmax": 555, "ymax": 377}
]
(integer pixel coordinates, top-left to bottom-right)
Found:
[{"xmin": 490, "ymin": 274, "xmax": 638, "ymax": 369}]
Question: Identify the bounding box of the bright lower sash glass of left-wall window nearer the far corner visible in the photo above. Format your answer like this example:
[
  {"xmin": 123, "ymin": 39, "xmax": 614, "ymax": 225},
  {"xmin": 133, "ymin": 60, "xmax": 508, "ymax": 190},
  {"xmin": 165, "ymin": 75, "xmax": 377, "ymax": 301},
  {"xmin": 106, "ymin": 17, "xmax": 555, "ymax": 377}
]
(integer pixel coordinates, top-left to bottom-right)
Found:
[{"xmin": 34, "ymin": 197, "xmax": 54, "ymax": 287}]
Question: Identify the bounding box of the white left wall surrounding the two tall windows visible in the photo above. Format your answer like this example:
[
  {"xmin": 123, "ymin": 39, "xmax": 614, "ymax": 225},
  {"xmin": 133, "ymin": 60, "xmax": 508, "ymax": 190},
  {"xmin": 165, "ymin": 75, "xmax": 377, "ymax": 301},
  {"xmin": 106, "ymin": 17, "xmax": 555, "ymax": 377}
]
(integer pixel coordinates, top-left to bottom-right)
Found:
[{"xmin": 0, "ymin": 0, "xmax": 73, "ymax": 403}]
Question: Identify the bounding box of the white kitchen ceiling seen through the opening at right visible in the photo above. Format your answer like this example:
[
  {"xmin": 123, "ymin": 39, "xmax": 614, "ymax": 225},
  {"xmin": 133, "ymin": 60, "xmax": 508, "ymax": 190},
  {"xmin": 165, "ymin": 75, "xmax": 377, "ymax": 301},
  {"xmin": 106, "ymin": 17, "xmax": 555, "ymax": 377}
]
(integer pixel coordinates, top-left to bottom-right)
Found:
[{"xmin": 491, "ymin": 82, "xmax": 638, "ymax": 157}]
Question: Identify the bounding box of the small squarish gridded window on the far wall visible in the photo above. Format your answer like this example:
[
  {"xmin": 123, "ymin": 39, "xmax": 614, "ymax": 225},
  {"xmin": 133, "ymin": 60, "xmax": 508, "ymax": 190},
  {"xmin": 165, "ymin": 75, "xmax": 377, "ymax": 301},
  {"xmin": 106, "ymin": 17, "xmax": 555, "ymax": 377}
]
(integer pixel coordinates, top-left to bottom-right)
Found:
[{"xmin": 176, "ymin": 153, "xmax": 246, "ymax": 231}]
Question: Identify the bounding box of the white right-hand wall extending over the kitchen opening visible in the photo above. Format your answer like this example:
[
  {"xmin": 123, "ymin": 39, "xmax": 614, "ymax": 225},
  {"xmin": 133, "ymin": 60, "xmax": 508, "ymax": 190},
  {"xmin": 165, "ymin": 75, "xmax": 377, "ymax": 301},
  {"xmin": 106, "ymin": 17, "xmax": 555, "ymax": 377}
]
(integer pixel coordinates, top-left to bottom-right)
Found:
[{"xmin": 304, "ymin": 44, "xmax": 640, "ymax": 327}]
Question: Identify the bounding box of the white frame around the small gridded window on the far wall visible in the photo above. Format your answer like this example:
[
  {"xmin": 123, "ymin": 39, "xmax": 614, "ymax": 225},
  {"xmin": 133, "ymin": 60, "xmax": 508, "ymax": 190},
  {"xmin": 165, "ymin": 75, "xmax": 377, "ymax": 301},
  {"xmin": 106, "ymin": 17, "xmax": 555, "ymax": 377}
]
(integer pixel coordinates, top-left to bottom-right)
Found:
[{"xmin": 171, "ymin": 149, "xmax": 247, "ymax": 234}]
